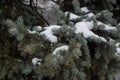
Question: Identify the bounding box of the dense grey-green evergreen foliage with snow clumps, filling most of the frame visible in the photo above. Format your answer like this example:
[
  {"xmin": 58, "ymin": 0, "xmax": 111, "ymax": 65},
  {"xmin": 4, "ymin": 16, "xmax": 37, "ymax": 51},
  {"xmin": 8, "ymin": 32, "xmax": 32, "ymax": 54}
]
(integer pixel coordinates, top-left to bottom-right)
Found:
[{"xmin": 0, "ymin": 0, "xmax": 120, "ymax": 80}]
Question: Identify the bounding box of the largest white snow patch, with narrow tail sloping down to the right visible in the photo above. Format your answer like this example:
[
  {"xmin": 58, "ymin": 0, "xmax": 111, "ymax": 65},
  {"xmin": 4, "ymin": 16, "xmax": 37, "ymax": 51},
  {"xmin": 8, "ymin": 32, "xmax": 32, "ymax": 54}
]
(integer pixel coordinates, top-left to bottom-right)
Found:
[{"xmin": 75, "ymin": 21, "xmax": 106, "ymax": 42}]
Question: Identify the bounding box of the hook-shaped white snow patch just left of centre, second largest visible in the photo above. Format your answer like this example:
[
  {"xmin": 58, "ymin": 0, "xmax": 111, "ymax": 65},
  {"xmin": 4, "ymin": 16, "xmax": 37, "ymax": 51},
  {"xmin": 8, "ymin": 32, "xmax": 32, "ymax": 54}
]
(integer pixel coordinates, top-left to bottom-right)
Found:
[{"xmin": 40, "ymin": 25, "xmax": 61, "ymax": 43}]
